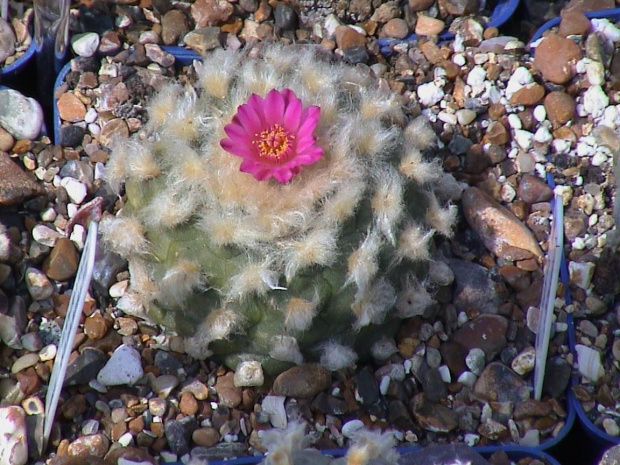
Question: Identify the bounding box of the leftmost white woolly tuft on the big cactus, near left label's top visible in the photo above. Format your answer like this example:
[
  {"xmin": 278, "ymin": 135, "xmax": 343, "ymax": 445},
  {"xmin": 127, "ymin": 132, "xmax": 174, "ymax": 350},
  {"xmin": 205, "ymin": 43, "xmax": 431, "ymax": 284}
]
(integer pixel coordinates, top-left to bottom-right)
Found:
[{"xmin": 99, "ymin": 215, "xmax": 150, "ymax": 258}]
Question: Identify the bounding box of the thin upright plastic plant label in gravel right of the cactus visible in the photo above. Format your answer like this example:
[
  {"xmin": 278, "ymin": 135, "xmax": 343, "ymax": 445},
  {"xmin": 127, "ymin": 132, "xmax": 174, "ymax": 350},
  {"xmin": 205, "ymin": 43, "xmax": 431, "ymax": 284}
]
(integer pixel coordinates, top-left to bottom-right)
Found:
[{"xmin": 534, "ymin": 195, "xmax": 564, "ymax": 400}]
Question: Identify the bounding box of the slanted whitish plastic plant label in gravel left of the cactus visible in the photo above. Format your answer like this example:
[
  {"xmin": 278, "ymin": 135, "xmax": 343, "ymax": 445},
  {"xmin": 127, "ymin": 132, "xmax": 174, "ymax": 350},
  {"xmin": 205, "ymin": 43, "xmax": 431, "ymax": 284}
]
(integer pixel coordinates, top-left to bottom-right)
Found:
[{"xmin": 43, "ymin": 221, "xmax": 98, "ymax": 450}]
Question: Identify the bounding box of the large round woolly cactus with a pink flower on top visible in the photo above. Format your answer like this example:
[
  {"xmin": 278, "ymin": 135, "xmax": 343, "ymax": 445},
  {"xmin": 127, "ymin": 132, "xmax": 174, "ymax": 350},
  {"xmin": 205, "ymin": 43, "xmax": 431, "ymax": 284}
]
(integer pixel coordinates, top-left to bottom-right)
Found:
[{"xmin": 101, "ymin": 45, "xmax": 456, "ymax": 374}]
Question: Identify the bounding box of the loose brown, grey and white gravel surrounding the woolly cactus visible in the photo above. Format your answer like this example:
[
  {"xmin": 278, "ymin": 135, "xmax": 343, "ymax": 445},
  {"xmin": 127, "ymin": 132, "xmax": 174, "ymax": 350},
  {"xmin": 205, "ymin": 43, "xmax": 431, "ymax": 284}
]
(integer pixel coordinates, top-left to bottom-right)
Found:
[{"xmin": 0, "ymin": 0, "xmax": 620, "ymax": 464}]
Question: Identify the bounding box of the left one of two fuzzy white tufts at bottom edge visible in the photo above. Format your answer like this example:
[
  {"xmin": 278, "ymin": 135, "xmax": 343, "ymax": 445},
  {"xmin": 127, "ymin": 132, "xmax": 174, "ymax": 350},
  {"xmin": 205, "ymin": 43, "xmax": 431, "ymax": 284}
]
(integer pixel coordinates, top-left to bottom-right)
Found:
[{"xmin": 259, "ymin": 421, "xmax": 312, "ymax": 465}]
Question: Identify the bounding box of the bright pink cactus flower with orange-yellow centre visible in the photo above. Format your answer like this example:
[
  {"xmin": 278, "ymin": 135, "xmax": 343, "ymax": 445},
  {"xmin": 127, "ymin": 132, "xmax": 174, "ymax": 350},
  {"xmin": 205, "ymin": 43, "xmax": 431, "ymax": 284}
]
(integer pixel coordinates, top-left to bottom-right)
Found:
[{"xmin": 220, "ymin": 89, "xmax": 323, "ymax": 184}]
